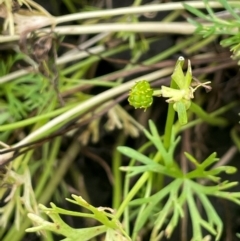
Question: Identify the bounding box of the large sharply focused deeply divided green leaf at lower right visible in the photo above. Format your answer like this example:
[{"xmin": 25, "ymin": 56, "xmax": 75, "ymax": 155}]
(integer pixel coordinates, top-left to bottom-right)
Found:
[{"xmin": 118, "ymin": 121, "xmax": 240, "ymax": 241}]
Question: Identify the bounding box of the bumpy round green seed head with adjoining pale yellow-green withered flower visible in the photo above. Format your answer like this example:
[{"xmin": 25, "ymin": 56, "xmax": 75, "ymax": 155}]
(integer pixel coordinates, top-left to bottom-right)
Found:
[{"xmin": 128, "ymin": 57, "xmax": 211, "ymax": 125}]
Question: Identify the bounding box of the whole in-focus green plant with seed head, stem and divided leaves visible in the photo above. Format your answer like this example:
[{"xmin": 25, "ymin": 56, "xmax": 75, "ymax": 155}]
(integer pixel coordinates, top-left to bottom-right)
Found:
[{"xmin": 23, "ymin": 57, "xmax": 240, "ymax": 241}]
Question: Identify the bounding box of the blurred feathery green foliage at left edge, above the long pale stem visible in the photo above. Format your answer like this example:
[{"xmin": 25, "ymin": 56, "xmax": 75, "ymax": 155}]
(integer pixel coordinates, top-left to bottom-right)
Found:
[{"xmin": 0, "ymin": 54, "xmax": 54, "ymax": 123}]
